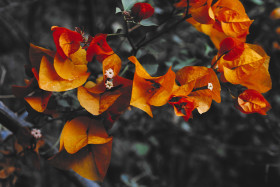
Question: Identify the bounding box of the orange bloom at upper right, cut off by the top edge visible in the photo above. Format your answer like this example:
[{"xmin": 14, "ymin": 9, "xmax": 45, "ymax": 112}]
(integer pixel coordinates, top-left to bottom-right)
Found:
[{"xmin": 187, "ymin": 0, "xmax": 253, "ymax": 49}]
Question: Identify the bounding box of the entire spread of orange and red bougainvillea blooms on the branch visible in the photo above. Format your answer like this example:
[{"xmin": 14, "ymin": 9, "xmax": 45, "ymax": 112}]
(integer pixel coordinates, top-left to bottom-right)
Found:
[{"xmin": 14, "ymin": 0, "xmax": 271, "ymax": 181}]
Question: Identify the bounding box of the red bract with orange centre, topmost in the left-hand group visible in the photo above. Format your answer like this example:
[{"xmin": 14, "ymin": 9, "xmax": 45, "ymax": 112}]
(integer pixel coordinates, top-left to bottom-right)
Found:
[{"xmin": 51, "ymin": 26, "xmax": 83, "ymax": 59}]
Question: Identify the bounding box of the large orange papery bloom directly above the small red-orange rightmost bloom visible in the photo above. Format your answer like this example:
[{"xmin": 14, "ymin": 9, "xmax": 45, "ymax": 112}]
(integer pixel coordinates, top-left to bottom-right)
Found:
[{"xmin": 214, "ymin": 44, "xmax": 272, "ymax": 93}]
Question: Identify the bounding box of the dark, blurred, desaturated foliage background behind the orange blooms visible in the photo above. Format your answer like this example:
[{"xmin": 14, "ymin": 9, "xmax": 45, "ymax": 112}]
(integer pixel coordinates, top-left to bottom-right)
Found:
[{"xmin": 0, "ymin": 0, "xmax": 280, "ymax": 187}]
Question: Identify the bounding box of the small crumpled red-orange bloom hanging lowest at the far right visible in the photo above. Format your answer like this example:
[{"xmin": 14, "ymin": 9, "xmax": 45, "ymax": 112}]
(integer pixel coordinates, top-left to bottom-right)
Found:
[{"xmin": 236, "ymin": 89, "xmax": 271, "ymax": 115}]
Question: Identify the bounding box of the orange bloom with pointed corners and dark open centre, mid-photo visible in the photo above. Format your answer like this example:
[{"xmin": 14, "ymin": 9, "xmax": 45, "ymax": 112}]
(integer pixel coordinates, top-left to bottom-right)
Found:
[{"xmin": 128, "ymin": 56, "xmax": 175, "ymax": 117}]
